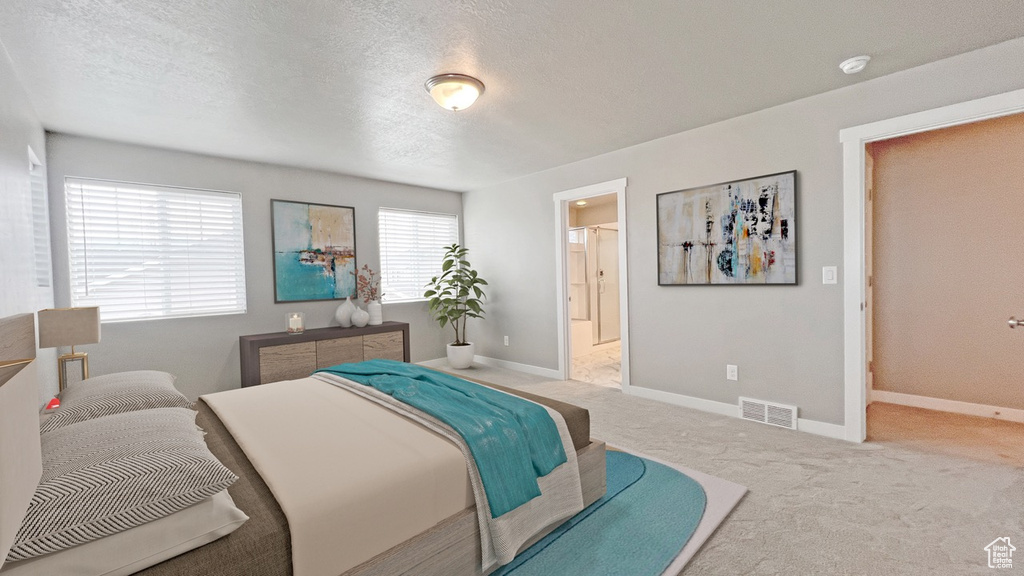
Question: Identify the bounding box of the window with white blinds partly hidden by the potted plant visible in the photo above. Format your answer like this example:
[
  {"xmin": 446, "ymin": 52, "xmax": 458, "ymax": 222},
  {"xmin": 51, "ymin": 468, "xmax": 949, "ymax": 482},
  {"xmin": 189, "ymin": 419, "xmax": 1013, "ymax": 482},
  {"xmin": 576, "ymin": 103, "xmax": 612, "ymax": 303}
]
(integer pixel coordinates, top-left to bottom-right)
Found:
[{"xmin": 377, "ymin": 208, "xmax": 459, "ymax": 302}]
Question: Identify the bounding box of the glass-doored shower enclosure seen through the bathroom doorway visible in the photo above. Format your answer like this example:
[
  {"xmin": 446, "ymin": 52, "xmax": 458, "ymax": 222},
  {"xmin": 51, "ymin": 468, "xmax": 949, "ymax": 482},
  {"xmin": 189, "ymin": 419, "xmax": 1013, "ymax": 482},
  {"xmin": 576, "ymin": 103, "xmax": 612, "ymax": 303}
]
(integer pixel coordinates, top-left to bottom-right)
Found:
[{"xmin": 568, "ymin": 225, "xmax": 620, "ymax": 354}]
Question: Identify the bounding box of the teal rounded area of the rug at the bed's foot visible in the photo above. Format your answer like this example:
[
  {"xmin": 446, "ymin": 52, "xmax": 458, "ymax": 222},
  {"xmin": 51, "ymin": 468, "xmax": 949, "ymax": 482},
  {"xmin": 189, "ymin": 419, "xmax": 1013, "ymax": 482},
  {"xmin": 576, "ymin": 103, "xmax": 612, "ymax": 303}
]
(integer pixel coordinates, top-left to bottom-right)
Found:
[{"xmin": 494, "ymin": 450, "xmax": 708, "ymax": 576}]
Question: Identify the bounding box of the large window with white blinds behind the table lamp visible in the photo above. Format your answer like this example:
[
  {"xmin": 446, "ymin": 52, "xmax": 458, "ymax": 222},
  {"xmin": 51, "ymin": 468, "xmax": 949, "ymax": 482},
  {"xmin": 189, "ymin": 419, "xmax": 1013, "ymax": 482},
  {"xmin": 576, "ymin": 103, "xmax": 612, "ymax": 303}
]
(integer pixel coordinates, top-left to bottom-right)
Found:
[{"xmin": 65, "ymin": 178, "xmax": 246, "ymax": 322}]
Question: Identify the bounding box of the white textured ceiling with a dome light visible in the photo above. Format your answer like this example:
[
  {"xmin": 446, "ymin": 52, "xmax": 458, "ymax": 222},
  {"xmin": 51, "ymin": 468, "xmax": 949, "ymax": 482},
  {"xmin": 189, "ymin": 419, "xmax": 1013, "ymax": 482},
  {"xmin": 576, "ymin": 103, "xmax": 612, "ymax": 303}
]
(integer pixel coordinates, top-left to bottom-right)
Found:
[{"xmin": 0, "ymin": 0, "xmax": 1024, "ymax": 191}]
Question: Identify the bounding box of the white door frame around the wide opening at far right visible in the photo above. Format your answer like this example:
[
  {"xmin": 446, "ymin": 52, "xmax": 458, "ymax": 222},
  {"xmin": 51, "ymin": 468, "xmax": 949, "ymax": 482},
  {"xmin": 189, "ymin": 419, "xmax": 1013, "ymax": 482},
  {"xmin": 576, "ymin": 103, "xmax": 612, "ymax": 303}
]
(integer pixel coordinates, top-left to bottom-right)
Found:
[{"xmin": 839, "ymin": 89, "xmax": 1024, "ymax": 442}]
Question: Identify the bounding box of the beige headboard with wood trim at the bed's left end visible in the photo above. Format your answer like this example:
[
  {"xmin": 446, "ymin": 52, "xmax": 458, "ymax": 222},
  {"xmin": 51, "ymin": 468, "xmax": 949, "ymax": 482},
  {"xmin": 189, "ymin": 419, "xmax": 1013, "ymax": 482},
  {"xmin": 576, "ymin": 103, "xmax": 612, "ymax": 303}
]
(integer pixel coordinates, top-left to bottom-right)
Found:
[{"xmin": 0, "ymin": 314, "xmax": 43, "ymax": 567}]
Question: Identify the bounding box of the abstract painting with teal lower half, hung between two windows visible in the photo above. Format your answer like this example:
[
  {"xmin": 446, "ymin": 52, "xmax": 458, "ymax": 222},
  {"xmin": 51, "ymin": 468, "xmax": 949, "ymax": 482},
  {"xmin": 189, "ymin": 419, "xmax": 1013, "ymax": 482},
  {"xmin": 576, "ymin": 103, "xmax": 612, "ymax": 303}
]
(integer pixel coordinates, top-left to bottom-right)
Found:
[{"xmin": 270, "ymin": 200, "xmax": 355, "ymax": 302}]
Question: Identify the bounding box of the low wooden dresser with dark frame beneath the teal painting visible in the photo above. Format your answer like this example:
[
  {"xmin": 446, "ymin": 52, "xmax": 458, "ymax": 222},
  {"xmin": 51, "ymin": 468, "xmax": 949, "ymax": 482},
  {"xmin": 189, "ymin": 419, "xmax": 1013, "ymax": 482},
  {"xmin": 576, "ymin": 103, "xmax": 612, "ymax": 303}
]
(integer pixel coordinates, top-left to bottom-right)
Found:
[{"xmin": 239, "ymin": 322, "xmax": 409, "ymax": 386}]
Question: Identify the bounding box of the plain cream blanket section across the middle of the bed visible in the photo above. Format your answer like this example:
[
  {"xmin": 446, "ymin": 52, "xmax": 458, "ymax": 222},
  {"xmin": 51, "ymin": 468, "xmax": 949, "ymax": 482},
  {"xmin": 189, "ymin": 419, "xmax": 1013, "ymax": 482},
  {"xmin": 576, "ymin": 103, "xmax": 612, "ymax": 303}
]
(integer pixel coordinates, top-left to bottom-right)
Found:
[{"xmin": 203, "ymin": 378, "xmax": 473, "ymax": 576}]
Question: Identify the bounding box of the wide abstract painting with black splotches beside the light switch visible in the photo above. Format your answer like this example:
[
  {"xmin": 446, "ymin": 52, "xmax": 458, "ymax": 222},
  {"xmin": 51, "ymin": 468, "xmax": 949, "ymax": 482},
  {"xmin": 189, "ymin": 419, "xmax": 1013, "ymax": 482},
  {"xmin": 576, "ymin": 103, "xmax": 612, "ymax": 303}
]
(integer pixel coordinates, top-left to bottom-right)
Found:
[{"xmin": 657, "ymin": 170, "xmax": 797, "ymax": 286}]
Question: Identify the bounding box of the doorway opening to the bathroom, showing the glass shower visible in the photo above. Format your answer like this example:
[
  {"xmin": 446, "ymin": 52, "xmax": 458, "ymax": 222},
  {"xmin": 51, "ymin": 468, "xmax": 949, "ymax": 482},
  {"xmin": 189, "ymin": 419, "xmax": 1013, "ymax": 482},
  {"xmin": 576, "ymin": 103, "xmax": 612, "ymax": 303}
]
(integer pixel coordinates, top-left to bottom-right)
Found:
[{"xmin": 554, "ymin": 178, "xmax": 629, "ymax": 389}]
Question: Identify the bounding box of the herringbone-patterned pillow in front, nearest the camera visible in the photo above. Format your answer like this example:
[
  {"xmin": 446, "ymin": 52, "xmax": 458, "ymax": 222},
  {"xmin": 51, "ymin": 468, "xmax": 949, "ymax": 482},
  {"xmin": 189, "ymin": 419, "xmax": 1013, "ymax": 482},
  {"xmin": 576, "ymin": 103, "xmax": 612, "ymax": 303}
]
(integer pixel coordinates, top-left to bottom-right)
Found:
[{"xmin": 7, "ymin": 408, "xmax": 238, "ymax": 562}]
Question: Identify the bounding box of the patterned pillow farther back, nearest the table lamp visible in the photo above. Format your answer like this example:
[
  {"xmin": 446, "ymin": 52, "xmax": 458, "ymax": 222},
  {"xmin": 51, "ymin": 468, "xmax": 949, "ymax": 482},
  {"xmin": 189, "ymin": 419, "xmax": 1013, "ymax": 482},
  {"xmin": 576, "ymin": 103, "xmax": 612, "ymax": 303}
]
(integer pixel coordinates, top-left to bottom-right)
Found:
[{"xmin": 39, "ymin": 370, "xmax": 193, "ymax": 433}]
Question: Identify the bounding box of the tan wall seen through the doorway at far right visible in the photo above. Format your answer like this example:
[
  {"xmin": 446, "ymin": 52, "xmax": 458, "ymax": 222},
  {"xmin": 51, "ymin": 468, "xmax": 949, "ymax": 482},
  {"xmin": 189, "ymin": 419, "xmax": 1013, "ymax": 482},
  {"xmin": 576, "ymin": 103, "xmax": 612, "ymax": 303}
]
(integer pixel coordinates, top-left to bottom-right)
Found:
[{"xmin": 871, "ymin": 115, "xmax": 1024, "ymax": 409}]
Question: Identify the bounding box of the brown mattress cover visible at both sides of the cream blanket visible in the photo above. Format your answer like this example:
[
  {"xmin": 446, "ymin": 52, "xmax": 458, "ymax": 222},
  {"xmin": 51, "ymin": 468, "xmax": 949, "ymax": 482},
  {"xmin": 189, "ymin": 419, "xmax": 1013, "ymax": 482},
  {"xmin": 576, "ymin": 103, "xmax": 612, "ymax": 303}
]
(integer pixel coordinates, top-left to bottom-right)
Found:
[{"xmin": 138, "ymin": 384, "xmax": 590, "ymax": 576}]
